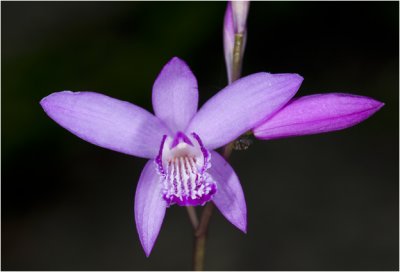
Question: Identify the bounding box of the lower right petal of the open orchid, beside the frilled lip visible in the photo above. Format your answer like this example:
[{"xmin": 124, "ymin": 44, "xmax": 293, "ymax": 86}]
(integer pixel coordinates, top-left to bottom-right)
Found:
[{"xmin": 208, "ymin": 151, "xmax": 247, "ymax": 233}]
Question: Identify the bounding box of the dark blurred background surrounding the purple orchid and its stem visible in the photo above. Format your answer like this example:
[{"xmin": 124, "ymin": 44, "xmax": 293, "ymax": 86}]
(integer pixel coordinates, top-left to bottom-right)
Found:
[{"xmin": 1, "ymin": 2, "xmax": 399, "ymax": 270}]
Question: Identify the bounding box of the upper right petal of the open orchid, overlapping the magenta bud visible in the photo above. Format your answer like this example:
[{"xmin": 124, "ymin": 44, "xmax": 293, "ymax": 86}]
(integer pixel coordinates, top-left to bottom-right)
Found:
[{"xmin": 186, "ymin": 73, "xmax": 303, "ymax": 149}]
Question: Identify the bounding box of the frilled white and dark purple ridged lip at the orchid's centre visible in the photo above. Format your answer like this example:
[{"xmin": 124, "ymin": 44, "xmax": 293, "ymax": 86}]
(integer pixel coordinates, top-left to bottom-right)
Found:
[{"xmin": 155, "ymin": 132, "xmax": 217, "ymax": 206}]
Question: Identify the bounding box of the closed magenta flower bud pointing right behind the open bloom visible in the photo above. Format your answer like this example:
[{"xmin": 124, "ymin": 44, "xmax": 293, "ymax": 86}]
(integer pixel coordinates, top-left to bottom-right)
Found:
[{"xmin": 254, "ymin": 93, "xmax": 384, "ymax": 140}]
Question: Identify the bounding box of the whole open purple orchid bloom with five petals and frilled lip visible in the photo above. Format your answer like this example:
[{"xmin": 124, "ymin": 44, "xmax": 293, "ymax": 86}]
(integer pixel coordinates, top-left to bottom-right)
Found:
[{"xmin": 40, "ymin": 57, "xmax": 303, "ymax": 256}]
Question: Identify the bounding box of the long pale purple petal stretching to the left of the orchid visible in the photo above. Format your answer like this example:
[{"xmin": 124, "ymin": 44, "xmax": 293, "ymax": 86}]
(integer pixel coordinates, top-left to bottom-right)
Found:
[{"xmin": 40, "ymin": 91, "xmax": 168, "ymax": 158}]
